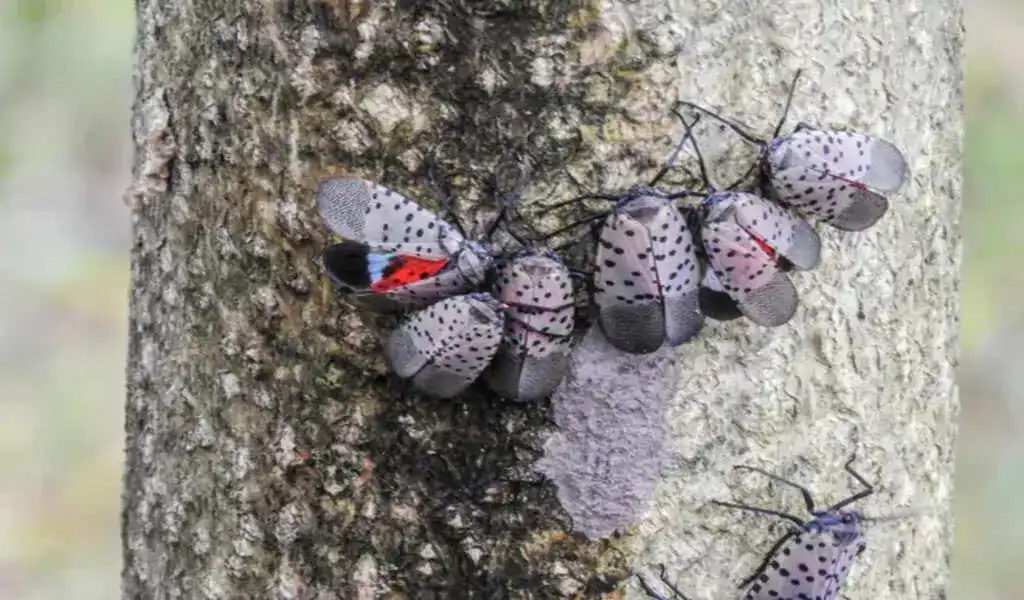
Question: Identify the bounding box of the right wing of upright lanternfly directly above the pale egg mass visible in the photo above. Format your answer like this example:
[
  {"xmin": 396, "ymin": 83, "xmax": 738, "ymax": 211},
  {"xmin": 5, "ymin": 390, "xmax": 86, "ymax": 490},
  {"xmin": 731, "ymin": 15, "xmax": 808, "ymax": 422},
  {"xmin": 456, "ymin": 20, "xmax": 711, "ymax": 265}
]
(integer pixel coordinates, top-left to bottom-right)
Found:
[{"xmin": 647, "ymin": 204, "xmax": 703, "ymax": 346}]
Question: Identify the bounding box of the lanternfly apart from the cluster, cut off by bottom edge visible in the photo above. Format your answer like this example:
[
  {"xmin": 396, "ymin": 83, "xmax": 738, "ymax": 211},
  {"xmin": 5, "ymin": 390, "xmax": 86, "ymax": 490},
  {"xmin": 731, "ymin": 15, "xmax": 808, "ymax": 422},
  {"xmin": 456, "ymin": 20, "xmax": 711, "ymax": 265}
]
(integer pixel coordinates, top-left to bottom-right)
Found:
[{"xmin": 712, "ymin": 458, "xmax": 874, "ymax": 600}]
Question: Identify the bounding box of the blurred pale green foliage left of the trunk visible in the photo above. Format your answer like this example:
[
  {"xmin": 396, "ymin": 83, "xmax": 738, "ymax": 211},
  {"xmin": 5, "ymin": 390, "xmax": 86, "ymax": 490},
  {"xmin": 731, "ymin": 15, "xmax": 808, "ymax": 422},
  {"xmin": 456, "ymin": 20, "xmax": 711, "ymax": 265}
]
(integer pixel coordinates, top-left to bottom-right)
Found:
[{"xmin": 0, "ymin": 0, "xmax": 134, "ymax": 600}]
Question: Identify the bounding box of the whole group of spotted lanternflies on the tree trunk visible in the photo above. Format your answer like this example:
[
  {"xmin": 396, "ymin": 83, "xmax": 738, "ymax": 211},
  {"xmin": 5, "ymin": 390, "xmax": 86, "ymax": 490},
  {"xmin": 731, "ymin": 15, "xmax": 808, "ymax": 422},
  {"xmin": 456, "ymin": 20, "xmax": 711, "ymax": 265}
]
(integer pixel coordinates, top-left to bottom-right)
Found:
[{"xmin": 316, "ymin": 72, "xmax": 906, "ymax": 600}]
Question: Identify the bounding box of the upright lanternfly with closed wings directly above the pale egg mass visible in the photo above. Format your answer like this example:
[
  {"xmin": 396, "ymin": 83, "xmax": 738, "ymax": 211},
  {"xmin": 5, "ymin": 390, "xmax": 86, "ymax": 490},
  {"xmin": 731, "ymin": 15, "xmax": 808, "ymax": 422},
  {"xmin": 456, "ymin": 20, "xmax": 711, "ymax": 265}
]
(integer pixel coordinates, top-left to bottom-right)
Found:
[{"xmin": 549, "ymin": 114, "xmax": 703, "ymax": 354}]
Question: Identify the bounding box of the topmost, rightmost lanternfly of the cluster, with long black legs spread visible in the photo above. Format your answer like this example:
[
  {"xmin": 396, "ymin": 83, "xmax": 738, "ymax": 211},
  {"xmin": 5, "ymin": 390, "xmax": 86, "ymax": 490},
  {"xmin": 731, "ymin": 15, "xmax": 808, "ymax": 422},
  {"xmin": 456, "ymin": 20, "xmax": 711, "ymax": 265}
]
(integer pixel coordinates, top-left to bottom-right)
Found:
[{"xmin": 681, "ymin": 71, "xmax": 907, "ymax": 231}]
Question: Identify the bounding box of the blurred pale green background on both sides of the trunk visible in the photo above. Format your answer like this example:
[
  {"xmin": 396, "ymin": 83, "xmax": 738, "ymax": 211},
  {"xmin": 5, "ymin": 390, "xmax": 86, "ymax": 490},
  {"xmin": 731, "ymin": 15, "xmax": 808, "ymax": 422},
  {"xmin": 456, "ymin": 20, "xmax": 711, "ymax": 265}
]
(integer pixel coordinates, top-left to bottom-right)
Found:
[{"xmin": 0, "ymin": 0, "xmax": 1007, "ymax": 600}]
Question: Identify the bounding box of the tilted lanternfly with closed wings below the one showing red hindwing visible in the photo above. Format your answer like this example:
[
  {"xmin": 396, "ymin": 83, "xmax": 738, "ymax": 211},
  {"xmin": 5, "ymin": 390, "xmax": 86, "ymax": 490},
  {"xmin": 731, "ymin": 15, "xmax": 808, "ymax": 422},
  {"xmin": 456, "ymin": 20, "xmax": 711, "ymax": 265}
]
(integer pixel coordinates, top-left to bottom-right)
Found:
[{"xmin": 384, "ymin": 293, "xmax": 506, "ymax": 398}]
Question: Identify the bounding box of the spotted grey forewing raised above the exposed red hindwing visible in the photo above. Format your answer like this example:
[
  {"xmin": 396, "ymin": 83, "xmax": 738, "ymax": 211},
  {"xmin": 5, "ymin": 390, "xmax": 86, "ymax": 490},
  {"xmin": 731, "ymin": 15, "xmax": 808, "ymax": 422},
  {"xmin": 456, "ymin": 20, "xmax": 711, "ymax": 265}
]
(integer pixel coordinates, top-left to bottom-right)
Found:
[{"xmin": 316, "ymin": 178, "xmax": 464, "ymax": 254}]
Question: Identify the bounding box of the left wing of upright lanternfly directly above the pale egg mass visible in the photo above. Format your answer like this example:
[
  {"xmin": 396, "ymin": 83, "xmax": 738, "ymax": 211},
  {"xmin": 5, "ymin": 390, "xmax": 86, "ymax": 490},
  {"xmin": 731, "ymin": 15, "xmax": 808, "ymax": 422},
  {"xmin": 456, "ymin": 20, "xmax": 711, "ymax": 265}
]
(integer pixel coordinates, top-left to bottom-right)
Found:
[{"xmin": 594, "ymin": 212, "xmax": 665, "ymax": 354}]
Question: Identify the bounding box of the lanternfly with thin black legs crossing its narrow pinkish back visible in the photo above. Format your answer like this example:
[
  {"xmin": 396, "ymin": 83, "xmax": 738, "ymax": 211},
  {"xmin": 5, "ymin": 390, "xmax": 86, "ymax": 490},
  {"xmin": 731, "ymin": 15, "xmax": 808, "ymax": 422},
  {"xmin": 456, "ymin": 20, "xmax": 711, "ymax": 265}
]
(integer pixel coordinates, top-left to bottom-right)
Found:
[{"xmin": 483, "ymin": 250, "xmax": 575, "ymax": 401}]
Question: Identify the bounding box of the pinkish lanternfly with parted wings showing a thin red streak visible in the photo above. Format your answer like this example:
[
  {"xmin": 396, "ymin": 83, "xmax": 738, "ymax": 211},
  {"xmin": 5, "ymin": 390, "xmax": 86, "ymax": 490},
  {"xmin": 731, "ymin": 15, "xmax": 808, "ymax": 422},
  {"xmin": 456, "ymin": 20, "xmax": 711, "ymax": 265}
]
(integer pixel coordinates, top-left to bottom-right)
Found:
[{"xmin": 699, "ymin": 191, "xmax": 821, "ymax": 327}]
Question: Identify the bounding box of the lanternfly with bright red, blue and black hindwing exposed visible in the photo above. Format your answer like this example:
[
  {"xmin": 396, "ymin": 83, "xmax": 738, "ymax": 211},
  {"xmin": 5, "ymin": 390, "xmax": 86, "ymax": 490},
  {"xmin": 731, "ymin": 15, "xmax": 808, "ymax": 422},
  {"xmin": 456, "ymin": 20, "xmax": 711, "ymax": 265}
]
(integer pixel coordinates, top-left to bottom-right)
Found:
[{"xmin": 316, "ymin": 178, "xmax": 494, "ymax": 310}]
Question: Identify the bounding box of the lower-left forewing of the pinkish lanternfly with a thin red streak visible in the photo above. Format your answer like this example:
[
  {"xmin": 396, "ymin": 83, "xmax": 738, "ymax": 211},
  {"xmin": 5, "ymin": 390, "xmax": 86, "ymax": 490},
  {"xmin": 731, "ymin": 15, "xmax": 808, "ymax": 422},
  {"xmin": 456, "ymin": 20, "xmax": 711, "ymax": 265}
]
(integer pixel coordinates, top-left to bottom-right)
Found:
[{"xmin": 700, "ymin": 201, "xmax": 800, "ymax": 327}]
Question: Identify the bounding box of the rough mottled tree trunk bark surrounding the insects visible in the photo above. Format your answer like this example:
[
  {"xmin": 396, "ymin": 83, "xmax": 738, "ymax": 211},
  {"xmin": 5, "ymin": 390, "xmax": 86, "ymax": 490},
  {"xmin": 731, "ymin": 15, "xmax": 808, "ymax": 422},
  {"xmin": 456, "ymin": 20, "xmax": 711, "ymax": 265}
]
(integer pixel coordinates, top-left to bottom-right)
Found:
[{"xmin": 123, "ymin": 0, "xmax": 963, "ymax": 600}]
